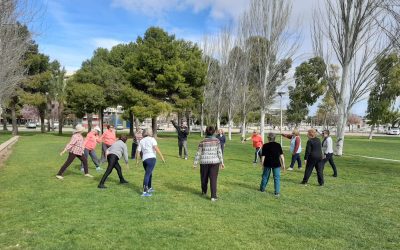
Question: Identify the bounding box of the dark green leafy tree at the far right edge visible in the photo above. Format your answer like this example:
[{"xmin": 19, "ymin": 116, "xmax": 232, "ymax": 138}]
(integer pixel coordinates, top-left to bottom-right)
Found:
[{"xmin": 367, "ymin": 53, "xmax": 400, "ymax": 139}]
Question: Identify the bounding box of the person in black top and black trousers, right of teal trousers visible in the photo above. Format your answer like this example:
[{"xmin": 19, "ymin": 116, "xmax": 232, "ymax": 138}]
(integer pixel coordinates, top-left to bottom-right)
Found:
[{"xmin": 301, "ymin": 129, "xmax": 324, "ymax": 186}]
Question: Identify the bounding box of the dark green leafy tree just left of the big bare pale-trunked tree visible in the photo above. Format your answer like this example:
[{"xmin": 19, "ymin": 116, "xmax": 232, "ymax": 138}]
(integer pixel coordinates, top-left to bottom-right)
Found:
[{"xmin": 287, "ymin": 57, "xmax": 326, "ymax": 126}]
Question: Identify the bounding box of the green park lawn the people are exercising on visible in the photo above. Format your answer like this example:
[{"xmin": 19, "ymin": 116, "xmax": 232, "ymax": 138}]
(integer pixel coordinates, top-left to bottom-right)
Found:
[{"xmin": 0, "ymin": 134, "xmax": 400, "ymax": 249}]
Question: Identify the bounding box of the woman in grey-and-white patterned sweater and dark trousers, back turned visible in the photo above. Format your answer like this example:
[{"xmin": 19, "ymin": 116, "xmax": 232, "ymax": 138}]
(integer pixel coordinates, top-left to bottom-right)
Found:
[{"xmin": 193, "ymin": 126, "xmax": 225, "ymax": 201}]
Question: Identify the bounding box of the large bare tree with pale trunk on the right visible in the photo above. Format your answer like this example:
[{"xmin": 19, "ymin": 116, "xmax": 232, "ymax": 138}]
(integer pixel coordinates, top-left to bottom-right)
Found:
[{"xmin": 312, "ymin": 0, "xmax": 386, "ymax": 155}]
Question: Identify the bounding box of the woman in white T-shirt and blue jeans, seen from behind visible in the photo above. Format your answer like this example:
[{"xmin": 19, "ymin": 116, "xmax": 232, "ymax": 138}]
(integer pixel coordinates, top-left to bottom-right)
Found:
[{"xmin": 136, "ymin": 129, "xmax": 165, "ymax": 197}]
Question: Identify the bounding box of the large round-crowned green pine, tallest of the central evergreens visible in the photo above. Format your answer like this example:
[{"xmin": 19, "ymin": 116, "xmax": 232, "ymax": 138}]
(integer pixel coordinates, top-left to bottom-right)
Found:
[{"xmin": 127, "ymin": 27, "xmax": 205, "ymax": 136}]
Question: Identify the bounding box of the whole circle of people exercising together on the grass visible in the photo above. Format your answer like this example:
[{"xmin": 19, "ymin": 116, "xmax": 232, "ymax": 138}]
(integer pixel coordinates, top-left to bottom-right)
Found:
[{"xmin": 56, "ymin": 121, "xmax": 337, "ymax": 201}]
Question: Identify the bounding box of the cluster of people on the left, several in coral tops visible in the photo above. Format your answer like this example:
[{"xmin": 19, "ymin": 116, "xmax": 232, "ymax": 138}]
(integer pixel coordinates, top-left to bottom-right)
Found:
[{"xmin": 56, "ymin": 124, "xmax": 165, "ymax": 197}]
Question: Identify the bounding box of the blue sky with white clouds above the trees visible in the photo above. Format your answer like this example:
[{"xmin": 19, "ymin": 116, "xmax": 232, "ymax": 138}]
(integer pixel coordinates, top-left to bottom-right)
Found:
[{"xmin": 34, "ymin": 0, "xmax": 366, "ymax": 115}]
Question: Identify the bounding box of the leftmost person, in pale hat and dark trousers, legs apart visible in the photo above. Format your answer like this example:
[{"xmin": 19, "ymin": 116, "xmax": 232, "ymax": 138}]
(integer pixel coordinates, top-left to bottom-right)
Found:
[{"xmin": 56, "ymin": 124, "xmax": 93, "ymax": 180}]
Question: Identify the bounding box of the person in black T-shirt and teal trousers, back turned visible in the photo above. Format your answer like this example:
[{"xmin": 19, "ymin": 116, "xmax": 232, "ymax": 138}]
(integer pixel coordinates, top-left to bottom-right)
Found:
[{"xmin": 260, "ymin": 133, "xmax": 285, "ymax": 197}]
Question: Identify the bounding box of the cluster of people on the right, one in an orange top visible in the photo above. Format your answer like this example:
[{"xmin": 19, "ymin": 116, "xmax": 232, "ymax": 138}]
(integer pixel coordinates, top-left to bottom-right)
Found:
[{"xmin": 244, "ymin": 129, "xmax": 338, "ymax": 197}]
